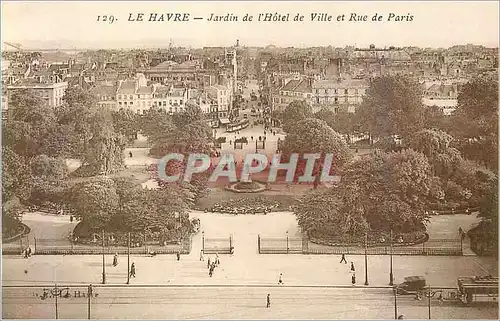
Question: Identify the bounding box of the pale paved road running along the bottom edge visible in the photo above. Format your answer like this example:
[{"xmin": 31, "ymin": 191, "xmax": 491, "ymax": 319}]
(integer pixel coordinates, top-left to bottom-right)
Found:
[{"xmin": 3, "ymin": 286, "xmax": 498, "ymax": 319}]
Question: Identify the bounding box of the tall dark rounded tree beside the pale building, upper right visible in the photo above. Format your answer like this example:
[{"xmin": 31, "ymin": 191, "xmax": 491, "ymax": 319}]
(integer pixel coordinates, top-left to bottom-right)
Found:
[{"xmin": 358, "ymin": 76, "xmax": 424, "ymax": 138}]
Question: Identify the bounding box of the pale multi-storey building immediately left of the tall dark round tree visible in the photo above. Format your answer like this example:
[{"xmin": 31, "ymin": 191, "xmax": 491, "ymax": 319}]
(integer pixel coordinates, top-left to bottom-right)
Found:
[{"xmin": 312, "ymin": 79, "xmax": 369, "ymax": 113}]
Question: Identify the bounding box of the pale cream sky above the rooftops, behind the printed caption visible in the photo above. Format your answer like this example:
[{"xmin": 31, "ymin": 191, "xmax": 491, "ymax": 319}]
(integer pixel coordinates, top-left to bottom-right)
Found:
[{"xmin": 1, "ymin": 1, "xmax": 499, "ymax": 49}]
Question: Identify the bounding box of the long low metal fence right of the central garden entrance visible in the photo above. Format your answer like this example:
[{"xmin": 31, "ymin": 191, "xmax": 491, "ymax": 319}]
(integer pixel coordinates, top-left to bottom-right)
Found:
[{"xmin": 257, "ymin": 235, "xmax": 463, "ymax": 256}]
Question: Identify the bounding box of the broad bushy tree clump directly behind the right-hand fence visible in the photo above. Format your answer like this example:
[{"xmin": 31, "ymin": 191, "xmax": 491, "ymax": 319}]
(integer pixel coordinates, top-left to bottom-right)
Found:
[{"xmin": 299, "ymin": 150, "xmax": 440, "ymax": 237}]
